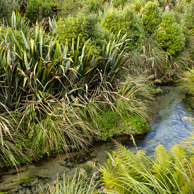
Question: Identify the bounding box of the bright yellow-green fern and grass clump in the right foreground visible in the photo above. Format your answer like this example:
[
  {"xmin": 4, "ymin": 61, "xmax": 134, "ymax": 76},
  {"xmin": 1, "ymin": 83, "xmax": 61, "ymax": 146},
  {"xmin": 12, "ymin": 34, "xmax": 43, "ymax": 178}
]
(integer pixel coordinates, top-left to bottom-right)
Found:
[{"xmin": 101, "ymin": 142, "xmax": 194, "ymax": 194}]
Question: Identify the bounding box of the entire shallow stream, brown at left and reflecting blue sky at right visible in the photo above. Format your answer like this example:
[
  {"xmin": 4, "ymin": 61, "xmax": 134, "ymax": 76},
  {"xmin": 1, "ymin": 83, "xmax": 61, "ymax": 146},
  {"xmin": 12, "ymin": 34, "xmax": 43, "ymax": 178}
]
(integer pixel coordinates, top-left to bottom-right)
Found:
[{"xmin": 0, "ymin": 86, "xmax": 194, "ymax": 194}]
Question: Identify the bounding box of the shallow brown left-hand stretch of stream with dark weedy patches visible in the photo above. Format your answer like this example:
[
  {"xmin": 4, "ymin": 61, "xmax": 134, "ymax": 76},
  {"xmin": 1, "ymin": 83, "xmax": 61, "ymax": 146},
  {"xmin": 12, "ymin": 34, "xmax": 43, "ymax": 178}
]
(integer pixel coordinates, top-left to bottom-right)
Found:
[{"xmin": 0, "ymin": 135, "xmax": 133, "ymax": 194}]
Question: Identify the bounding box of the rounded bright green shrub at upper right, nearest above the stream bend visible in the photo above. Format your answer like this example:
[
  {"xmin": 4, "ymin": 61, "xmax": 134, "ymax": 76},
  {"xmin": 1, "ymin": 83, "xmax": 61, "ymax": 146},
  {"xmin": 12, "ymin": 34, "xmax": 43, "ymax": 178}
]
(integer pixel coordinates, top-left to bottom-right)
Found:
[{"xmin": 155, "ymin": 13, "xmax": 185, "ymax": 56}]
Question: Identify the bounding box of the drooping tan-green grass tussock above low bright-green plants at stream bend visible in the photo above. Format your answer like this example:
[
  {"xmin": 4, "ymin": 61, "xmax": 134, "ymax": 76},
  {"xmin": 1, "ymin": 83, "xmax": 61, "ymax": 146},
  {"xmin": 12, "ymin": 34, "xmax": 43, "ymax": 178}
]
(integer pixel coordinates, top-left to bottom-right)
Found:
[{"xmin": 116, "ymin": 76, "xmax": 153, "ymax": 120}]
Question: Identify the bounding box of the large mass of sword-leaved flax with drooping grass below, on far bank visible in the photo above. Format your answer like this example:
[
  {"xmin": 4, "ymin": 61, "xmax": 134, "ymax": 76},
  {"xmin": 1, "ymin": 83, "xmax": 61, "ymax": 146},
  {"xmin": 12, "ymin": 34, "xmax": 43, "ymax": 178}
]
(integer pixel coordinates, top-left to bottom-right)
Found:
[{"xmin": 0, "ymin": 13, "xmax": 155, "ymax": 166}]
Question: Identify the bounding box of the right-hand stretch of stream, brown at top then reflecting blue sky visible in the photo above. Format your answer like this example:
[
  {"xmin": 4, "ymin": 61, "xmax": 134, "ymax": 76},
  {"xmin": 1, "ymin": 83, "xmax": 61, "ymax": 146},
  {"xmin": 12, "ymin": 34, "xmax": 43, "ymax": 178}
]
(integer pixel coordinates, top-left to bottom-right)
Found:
[{"xmin": 124, "ymin": 87, "xmax": 194, "ymax": 154}]
